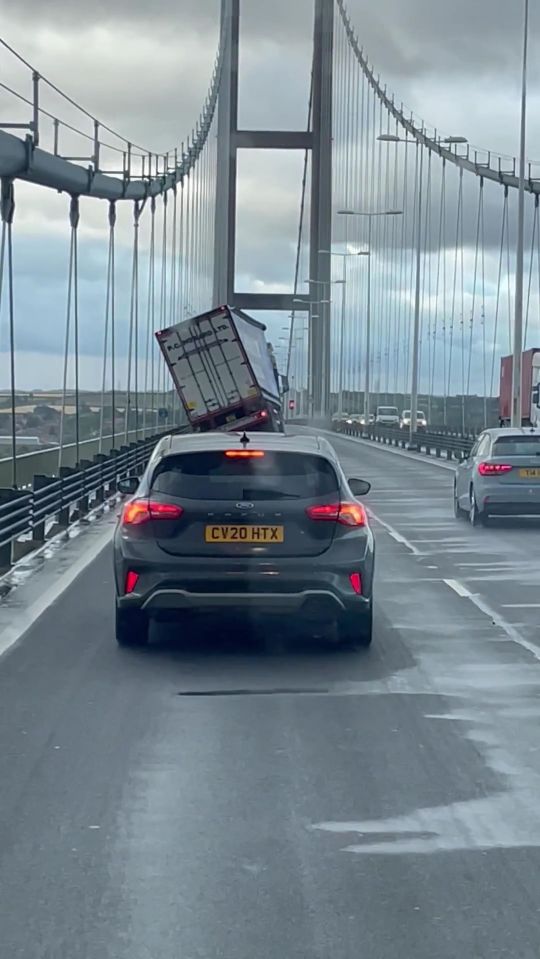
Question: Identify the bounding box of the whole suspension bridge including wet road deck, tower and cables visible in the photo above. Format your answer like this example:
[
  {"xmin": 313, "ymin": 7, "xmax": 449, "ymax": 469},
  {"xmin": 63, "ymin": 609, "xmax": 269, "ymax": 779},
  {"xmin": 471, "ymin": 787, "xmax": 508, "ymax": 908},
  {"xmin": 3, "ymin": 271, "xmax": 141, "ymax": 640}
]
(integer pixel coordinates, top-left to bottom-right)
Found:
[{"xmin": 0, "ymin": 7, "xmax": 540, "ymax": 959}]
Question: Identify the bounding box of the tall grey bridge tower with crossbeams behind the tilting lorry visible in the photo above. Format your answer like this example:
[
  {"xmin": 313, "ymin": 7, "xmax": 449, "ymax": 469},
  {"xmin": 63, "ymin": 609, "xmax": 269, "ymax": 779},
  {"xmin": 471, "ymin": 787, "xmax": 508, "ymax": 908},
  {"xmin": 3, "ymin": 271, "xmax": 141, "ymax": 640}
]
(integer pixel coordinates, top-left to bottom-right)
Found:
[{"xmin": 214, "ymin": 0, "xmax": 334, "ymax": 415}]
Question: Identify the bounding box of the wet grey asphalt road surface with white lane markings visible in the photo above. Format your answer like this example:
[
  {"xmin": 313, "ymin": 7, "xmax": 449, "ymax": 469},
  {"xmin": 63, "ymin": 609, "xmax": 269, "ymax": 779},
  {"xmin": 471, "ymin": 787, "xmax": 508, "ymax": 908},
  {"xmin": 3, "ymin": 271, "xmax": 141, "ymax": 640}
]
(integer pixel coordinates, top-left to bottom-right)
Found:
[{"xmin": 0, "ymin": 439, "xmax": 540, "ymax": 959}]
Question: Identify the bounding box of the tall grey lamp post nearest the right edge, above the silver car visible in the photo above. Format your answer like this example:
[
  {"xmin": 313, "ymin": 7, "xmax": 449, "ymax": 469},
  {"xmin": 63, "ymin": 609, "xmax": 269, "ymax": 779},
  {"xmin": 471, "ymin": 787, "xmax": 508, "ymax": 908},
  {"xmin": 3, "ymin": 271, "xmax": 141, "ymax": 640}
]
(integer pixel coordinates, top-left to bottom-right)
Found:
[{"xmin": 511, "ymin": 0, "xmax": 529, "ymax": 427}]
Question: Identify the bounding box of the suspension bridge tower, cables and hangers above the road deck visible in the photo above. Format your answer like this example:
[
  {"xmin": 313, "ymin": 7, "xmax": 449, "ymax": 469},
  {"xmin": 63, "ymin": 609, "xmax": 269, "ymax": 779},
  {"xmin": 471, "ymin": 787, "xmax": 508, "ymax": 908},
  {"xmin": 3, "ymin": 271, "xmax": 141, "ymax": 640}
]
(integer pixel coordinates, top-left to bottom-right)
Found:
[{"xmin": 0, "ymin": 0, "xmax": 540, "ymax": 488}]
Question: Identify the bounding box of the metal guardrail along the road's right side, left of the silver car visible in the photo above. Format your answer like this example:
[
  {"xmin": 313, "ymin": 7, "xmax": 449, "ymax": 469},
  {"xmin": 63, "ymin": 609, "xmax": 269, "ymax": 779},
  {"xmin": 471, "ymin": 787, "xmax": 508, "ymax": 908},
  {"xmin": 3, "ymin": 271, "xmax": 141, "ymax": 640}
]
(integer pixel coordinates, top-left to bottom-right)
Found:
[{"xmin": 333, "ymin": 423, "xmax": 476, "ymax": 460}]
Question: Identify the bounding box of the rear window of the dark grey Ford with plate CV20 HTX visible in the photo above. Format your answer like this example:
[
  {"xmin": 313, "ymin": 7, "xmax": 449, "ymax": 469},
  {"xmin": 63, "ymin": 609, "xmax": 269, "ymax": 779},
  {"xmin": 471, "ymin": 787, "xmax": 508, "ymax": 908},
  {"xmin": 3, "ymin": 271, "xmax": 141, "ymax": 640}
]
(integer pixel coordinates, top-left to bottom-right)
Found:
[{"xmin": 152, "ymin": 450, "xmax": 339, "ymax": 501}]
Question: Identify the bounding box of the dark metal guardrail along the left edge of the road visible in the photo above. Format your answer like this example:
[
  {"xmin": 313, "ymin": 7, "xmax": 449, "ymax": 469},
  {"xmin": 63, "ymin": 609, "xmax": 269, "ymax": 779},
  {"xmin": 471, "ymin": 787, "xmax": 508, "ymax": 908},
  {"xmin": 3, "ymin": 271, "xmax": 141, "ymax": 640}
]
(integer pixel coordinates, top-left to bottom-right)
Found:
[{"xmin": 0, "ymin": 430, "xmax": 183, "ymax": 573}]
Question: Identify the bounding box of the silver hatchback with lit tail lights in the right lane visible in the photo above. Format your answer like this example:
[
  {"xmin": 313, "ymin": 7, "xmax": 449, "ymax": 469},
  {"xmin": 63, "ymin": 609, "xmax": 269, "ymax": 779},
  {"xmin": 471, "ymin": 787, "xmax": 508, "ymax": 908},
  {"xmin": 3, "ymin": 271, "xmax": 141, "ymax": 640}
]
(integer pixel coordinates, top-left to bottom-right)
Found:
[{"xmin": 454, "ymin": 427, "xmax": 540, "ymax": 526}]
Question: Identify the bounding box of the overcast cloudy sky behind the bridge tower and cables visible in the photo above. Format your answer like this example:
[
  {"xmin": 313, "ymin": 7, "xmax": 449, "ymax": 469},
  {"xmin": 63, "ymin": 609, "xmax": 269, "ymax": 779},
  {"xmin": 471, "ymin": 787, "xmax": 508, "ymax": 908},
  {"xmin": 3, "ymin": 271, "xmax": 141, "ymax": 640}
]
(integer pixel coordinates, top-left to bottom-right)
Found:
[{"xmin": 0, "ymin": 0, "xmax": 540, "ymax": 396}]
